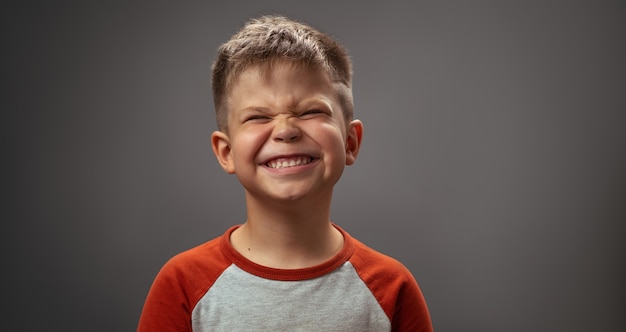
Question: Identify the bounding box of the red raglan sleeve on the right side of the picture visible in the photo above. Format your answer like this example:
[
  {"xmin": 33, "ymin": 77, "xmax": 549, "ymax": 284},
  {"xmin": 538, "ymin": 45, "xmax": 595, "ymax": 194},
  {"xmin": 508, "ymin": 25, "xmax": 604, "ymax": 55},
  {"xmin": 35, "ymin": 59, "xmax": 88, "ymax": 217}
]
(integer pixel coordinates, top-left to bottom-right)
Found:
[{"xmin": 350, "ymin": 240, "xmax": 433, "ymax": 332}]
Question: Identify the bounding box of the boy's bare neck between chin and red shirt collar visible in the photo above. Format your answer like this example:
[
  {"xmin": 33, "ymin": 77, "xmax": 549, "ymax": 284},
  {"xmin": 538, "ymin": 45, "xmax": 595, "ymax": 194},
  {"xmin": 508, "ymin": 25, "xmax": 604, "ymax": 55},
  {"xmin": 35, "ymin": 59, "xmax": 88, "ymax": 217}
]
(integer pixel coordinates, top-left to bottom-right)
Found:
[{"xmin": 231, "ymin": 192, "xmax": 343, "ymax": 269}]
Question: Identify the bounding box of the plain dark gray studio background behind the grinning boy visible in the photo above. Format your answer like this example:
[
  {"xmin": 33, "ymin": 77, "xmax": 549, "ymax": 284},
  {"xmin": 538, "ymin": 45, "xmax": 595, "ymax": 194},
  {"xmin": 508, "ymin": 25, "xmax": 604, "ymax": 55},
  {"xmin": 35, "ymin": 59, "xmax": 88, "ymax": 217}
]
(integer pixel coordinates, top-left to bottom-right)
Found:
[{"xmin": 0, "ymin": 1, "xmax": 626, "ymax": 332}]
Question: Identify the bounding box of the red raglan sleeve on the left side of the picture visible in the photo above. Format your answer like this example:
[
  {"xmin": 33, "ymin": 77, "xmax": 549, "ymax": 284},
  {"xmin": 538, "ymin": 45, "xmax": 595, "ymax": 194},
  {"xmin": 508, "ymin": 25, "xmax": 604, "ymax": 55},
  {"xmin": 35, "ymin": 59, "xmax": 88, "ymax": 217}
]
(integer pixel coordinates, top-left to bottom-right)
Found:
[{"xmin": 137, "ymin": 239, "xmax": 230, "ymax": 332}]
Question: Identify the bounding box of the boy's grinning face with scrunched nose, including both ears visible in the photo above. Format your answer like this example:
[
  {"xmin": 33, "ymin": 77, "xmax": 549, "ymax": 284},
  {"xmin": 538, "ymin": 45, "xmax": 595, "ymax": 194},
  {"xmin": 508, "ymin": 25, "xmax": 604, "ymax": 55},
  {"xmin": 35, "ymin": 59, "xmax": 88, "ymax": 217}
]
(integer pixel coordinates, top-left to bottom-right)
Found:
[{"xmin": 212, "ymin": 62, "xmax": 363, "ymax": 201}]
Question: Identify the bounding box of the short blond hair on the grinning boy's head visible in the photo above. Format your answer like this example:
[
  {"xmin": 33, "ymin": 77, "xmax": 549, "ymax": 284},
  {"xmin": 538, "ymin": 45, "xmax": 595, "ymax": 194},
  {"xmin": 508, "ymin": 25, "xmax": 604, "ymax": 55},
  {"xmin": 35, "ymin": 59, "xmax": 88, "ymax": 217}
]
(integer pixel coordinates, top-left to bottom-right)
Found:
[{"xmin": 211, "ymin": 15, "xmax": 354, "ymax": 131}]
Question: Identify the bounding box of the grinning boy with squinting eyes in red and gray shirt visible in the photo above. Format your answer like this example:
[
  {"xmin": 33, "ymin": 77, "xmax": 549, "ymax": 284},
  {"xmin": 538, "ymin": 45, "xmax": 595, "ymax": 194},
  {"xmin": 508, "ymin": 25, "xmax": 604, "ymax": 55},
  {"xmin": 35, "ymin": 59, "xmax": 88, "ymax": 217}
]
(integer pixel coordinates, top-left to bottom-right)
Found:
[{"xmin": 138, "ymin": 16, "xmax": 432, "ymax": 332}]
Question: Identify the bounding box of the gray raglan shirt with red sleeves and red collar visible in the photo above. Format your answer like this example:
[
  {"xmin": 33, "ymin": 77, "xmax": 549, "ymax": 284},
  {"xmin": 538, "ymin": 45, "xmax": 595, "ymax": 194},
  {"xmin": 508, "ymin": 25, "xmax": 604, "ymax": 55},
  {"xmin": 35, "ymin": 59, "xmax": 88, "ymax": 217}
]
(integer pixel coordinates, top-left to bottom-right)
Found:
[{"xmin": 138, "ymin": 225, "xmax": 432, "ymax": 332}]
